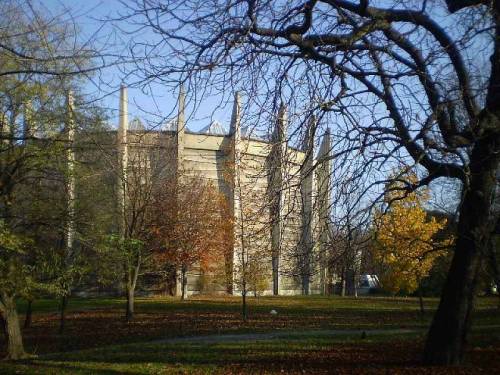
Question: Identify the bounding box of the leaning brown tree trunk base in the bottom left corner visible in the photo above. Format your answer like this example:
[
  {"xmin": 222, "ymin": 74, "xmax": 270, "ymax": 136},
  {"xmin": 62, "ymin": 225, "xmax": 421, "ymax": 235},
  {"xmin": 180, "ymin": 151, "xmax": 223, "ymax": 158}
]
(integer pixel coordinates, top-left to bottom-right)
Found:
[{"xmin": 1, "ymin": 296, "xmax": 28, "ymax": 360}]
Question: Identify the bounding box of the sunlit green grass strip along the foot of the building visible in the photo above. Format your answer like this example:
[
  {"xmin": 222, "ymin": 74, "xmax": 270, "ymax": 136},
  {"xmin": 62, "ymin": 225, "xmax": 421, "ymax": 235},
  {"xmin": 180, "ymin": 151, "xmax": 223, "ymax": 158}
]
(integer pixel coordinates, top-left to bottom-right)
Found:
[{"xmin": 14, "ymin": 296, "xmax": 500, "ymax": 331}]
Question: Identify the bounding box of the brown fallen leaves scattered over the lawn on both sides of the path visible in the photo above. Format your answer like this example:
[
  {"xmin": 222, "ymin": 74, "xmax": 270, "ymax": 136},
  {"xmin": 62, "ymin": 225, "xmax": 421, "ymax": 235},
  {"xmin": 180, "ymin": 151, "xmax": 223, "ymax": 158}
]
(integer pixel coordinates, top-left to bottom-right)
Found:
[{"xmin": 0, "ymin": 297, "xmax": 500, "ymax": 374}]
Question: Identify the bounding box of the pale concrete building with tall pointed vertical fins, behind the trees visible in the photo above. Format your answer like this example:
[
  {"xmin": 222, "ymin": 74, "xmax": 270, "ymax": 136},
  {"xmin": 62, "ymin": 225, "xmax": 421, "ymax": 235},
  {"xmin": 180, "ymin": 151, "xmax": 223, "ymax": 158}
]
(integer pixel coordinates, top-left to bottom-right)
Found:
[{"xmin": 116, "ymin": 87, "xmax": 331, "ymax": 295}]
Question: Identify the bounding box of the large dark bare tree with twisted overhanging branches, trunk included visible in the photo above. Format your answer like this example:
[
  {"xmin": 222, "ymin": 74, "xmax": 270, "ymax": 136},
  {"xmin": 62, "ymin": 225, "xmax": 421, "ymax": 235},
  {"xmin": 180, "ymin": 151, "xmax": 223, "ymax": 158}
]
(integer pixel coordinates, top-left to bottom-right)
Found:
[{"xmin": 124, "ymin": 0, "xmax": 500, "ymax": 364}]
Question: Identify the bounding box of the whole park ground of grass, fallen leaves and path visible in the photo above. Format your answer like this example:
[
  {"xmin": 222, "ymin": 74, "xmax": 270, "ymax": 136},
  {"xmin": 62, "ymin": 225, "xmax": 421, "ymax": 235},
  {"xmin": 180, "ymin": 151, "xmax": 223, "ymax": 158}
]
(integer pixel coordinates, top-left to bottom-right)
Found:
[{"xmin": 0, "ymin": 296, "xmax": 500, "ymax": 374}]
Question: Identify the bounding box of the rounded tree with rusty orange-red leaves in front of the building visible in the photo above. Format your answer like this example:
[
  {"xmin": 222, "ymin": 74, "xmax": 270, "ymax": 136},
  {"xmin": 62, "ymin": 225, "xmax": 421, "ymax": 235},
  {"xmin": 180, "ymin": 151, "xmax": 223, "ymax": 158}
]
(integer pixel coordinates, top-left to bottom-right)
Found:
[{"xmin": 150, "ymin": 172, "xmax": 232, "ymax": 299}]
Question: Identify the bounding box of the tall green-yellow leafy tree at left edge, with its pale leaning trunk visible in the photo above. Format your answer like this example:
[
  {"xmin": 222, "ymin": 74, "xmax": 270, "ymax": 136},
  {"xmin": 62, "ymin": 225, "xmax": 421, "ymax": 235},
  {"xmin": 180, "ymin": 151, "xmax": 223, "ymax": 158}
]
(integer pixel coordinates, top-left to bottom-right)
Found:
[{"xmin": 0, "ymin": 0, "xmax": 109, "ymax": 359}]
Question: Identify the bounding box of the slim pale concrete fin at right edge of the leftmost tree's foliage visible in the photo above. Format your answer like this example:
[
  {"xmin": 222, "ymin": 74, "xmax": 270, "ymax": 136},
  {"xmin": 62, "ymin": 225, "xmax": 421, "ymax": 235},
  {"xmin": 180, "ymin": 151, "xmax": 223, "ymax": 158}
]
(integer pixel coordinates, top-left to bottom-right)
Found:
[{"xmin": 66, "ymin": 91, "xmax": 76, "ymax": 260}]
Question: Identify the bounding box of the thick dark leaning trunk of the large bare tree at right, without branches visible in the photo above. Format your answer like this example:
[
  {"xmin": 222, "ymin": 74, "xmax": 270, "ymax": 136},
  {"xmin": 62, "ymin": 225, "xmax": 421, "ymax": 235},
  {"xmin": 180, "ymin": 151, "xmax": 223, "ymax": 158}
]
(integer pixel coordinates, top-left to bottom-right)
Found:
[{"xmin": 424, "ymin": 135, "xmax": 500, "ymax": 365}]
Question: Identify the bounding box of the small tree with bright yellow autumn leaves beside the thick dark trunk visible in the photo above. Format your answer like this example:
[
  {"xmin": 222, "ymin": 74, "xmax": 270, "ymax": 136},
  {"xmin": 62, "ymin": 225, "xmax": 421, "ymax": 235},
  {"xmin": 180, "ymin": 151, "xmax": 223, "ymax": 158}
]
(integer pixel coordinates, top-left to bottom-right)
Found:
[{"xmin": 373, "ymin": 174, "xmax": 450, "ymax": 312}]
